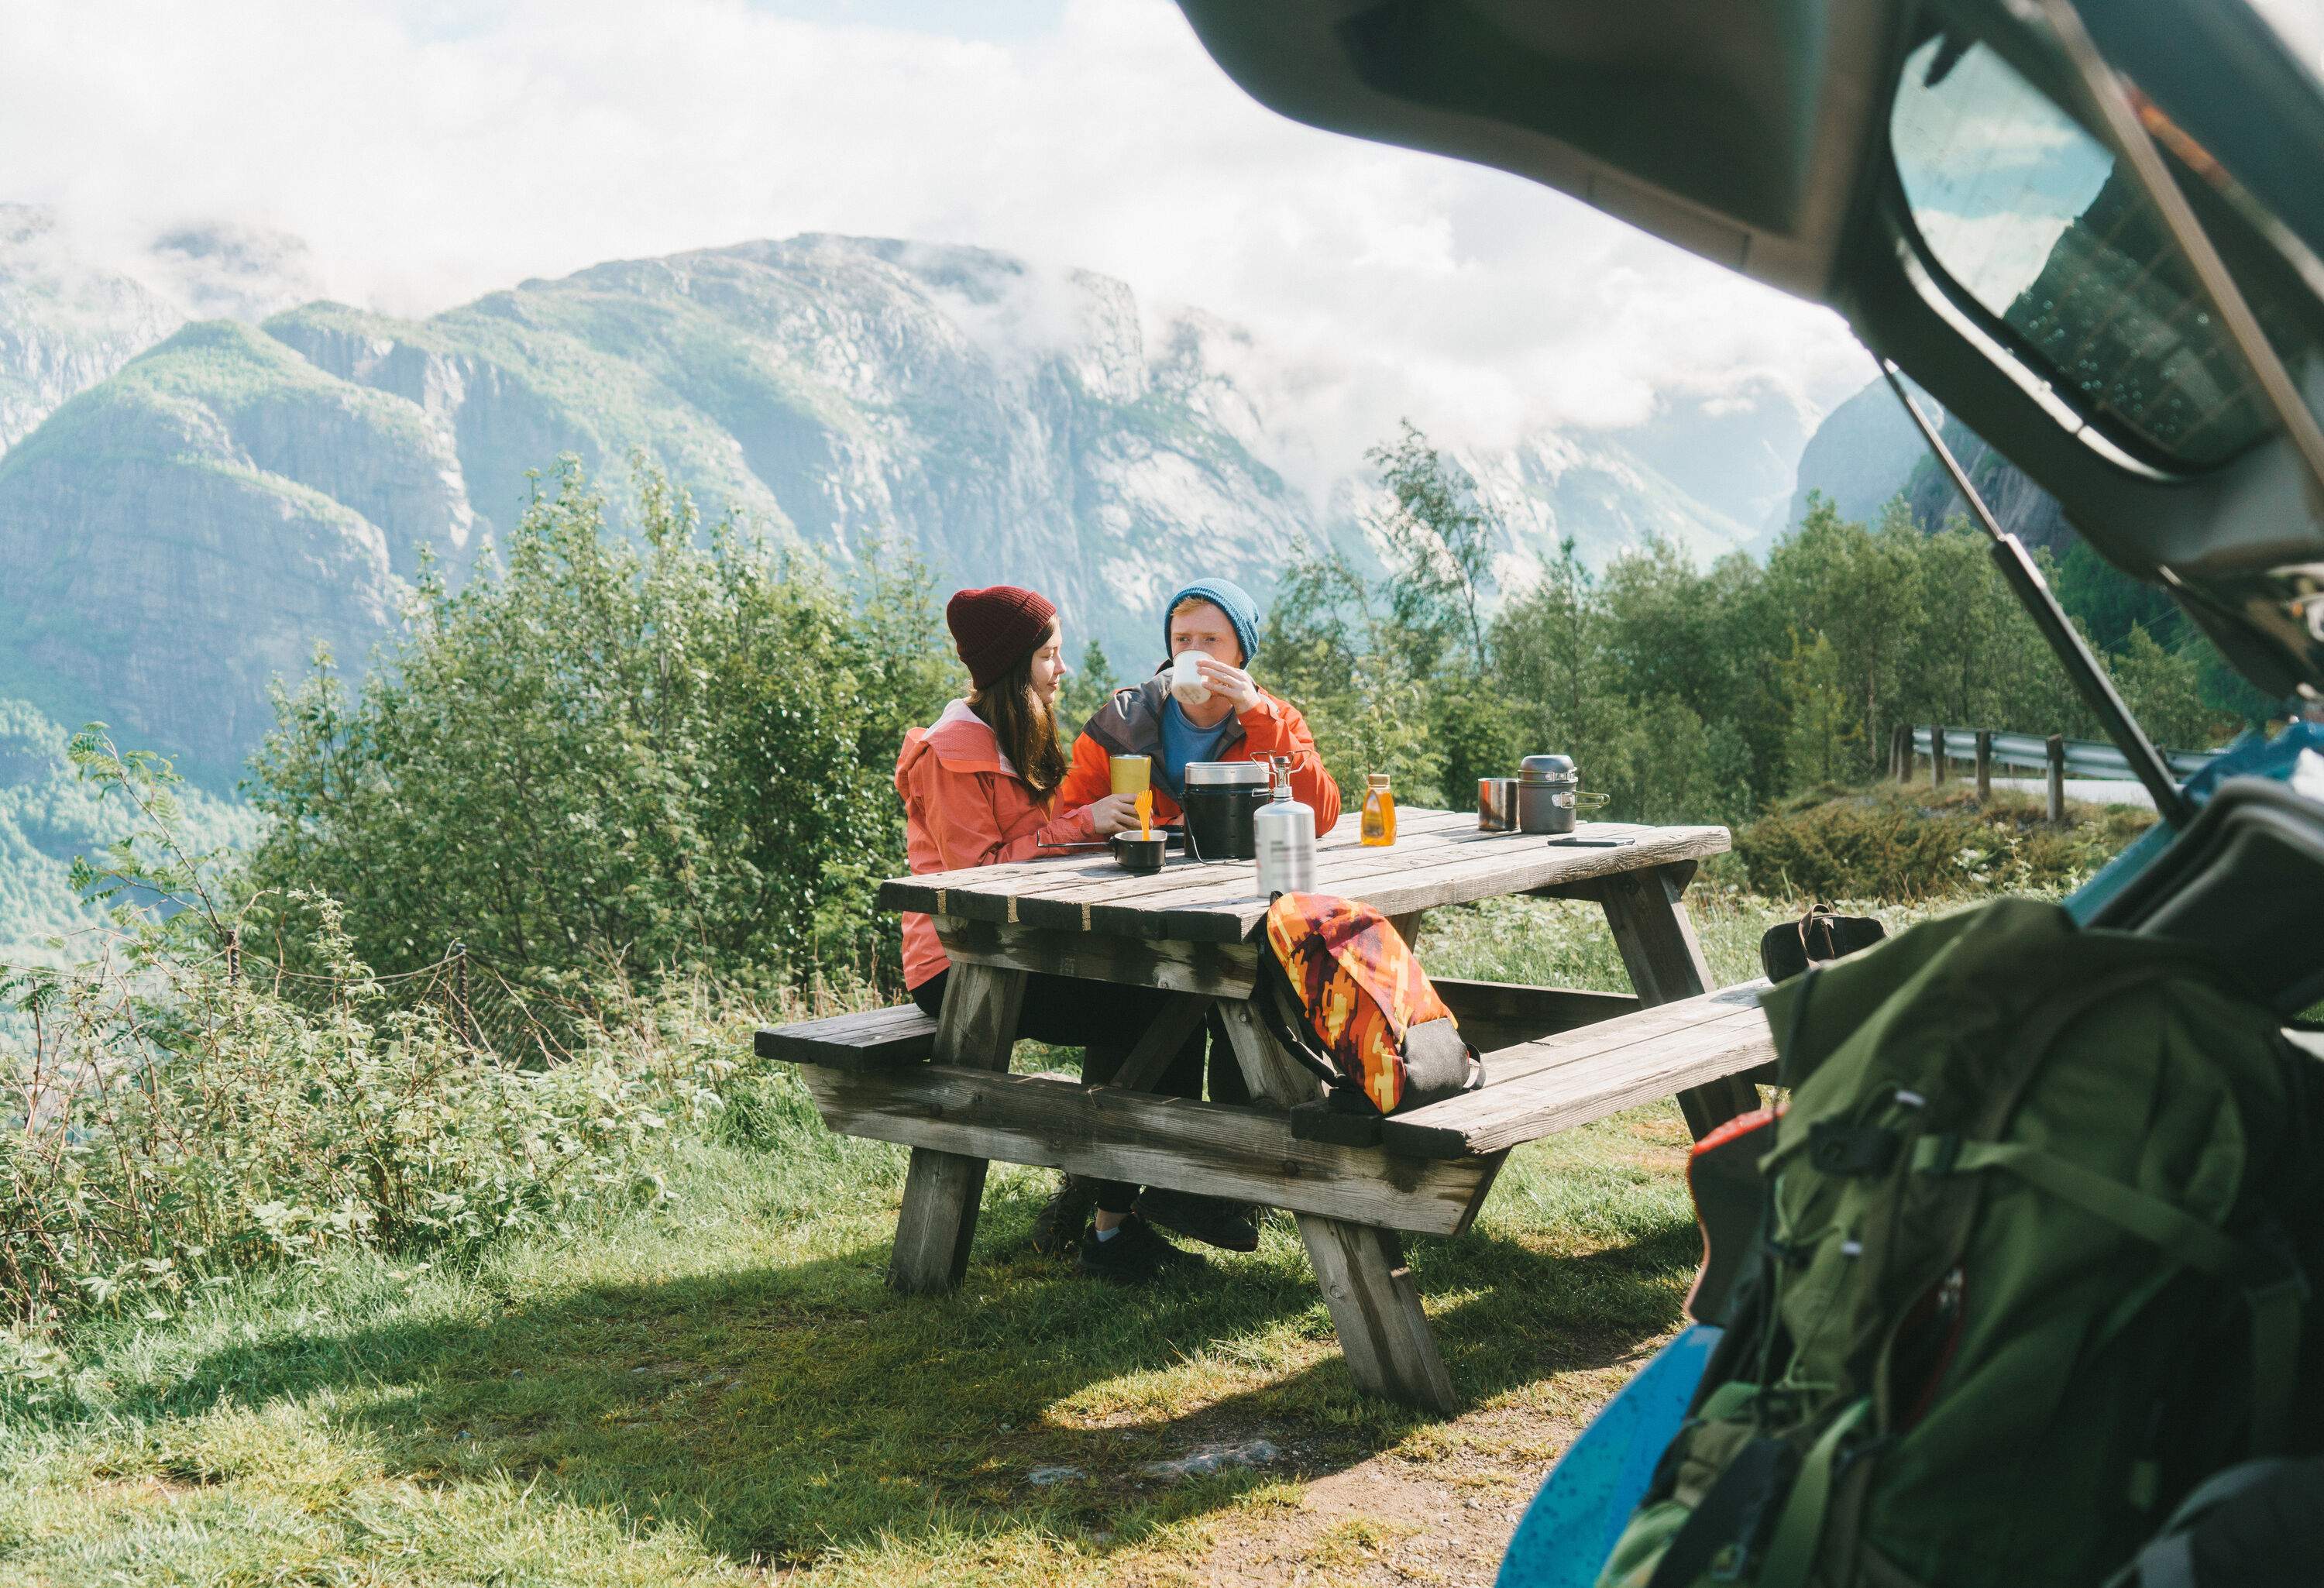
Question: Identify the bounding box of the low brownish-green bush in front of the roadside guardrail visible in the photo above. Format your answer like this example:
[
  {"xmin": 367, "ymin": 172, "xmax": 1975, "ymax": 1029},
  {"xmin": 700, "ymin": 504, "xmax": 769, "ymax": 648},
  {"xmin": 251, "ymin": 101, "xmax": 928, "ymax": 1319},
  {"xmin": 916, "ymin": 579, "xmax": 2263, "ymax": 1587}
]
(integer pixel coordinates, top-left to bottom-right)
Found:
[{"xmin": 1736, "ymin": 785, "xmax": 2154, "ymax": 902}]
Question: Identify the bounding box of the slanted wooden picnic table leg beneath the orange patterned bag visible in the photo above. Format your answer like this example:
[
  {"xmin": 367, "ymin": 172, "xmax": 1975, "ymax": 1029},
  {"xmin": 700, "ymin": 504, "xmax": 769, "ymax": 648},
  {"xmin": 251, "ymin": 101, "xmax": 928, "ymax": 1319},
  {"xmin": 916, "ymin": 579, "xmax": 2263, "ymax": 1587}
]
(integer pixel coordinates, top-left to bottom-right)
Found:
[{"xmin": 1218, "ymin": 1000, "xmax": 1455, "ymax": 1414}]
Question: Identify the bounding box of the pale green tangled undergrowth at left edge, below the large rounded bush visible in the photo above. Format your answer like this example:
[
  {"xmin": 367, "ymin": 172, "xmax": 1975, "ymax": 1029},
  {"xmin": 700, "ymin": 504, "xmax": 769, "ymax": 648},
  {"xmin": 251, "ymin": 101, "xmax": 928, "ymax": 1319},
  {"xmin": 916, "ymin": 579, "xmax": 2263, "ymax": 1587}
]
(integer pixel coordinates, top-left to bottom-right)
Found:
[{"xmin": 0, "ymin": 732, "xmax": 725, "ymax": 1329}]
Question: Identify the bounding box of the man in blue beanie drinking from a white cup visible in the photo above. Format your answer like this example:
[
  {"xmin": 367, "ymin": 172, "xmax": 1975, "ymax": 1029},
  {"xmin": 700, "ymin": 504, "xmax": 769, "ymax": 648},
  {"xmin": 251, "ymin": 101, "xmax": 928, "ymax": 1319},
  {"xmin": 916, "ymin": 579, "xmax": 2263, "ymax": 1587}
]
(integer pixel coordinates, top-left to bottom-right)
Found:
[{"xmin": 1034, "ymin": 579, "xmax": 1339, "ymax": 1251}]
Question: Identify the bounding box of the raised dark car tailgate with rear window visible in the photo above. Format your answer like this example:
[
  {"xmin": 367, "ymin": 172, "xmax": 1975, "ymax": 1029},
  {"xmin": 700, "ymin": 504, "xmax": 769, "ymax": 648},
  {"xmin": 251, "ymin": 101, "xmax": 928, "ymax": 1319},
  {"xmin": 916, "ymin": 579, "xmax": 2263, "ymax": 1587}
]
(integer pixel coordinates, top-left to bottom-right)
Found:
[{"xmin": 1181, "ymin": 0, "xmax": 2324, "ymax": 697}]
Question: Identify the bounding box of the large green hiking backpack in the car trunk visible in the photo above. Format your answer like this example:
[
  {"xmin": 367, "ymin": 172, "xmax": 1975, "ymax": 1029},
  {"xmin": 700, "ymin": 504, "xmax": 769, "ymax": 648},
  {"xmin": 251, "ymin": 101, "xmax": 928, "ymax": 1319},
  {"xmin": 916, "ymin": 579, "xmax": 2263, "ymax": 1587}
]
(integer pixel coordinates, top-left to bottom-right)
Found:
[{"xmin": 1599, "ymin": 900, "xmax": 2324, "ymax": 1588}]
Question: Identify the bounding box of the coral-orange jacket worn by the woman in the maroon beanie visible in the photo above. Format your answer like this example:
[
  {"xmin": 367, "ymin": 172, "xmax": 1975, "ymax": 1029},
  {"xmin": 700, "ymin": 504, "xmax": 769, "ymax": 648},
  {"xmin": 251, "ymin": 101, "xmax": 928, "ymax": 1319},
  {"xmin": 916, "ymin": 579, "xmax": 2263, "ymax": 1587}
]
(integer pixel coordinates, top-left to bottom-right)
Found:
[{"xmin": 895, "ymin": 699, "xmax": 1097, "ymax": 988}]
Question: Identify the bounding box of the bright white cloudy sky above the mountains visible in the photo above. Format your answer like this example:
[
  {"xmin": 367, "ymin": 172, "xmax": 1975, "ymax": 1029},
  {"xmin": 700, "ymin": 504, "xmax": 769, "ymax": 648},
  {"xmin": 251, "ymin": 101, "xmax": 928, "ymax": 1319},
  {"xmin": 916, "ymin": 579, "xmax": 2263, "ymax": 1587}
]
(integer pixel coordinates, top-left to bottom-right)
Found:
[{"xmin": 0, "ymin": 0, "xmax": 1871, "ymax": 472}]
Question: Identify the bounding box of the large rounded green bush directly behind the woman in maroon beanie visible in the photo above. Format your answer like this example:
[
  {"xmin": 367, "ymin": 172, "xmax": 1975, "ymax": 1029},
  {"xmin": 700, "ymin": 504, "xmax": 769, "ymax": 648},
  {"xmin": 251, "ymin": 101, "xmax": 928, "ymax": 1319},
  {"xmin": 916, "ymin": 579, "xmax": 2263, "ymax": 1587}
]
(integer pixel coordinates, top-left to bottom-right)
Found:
[{"xmin": 251, "ymin": 458, "xmax": 953, "ymax": 986}]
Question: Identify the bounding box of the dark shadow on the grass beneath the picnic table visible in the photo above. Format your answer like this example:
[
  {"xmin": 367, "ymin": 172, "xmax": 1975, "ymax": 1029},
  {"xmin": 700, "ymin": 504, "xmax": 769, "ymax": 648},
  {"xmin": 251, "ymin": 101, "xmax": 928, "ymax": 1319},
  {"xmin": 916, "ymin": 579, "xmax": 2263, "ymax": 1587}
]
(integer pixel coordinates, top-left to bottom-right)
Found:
[{"xmin": 140, "ymin": 1198, "xmax": 1694, "ymax": 1565}]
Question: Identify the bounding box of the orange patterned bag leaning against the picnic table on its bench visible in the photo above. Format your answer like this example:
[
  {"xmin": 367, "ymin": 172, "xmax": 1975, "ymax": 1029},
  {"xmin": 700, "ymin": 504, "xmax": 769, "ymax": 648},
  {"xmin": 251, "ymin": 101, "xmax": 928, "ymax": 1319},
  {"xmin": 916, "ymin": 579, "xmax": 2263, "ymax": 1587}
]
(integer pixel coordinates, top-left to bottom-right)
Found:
[{"xmin": 1260, "ymin": 893, "xmax": 1485, "ymax": 1114}]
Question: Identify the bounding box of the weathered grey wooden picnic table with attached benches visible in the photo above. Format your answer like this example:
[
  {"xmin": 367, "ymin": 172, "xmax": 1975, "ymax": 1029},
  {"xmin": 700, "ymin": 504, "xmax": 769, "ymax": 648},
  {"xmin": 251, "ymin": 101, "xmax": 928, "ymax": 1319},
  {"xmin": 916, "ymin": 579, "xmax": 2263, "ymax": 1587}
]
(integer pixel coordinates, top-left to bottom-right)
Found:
[{"xmin": 758, "ymin": 809, "xmax": 1773, "ymax": 1411}]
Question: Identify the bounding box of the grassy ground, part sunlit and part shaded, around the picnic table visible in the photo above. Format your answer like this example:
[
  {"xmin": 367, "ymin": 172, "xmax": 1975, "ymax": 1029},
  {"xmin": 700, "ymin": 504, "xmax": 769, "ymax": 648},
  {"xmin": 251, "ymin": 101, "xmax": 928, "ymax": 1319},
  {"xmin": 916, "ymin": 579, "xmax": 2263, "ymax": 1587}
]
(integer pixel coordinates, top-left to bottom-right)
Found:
[{"xmin": 0, "ymin": 886, "xmax": 1961, "ymax": 1586}]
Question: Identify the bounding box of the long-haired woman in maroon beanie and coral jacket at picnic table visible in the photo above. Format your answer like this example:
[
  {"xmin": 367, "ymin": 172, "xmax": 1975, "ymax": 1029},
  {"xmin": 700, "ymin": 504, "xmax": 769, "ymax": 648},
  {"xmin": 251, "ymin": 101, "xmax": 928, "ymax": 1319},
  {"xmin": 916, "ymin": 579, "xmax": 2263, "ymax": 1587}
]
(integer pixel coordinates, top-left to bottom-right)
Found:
[{"xmin": 895, "ymin": 583, "xmax": 1204, "ymax": 1284}]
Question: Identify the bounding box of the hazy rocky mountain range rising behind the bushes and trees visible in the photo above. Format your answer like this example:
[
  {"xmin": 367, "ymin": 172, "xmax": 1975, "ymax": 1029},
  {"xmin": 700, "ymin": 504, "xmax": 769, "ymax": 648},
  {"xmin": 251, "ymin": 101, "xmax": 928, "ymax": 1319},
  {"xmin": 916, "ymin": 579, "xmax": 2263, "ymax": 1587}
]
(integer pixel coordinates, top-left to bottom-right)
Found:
[{"xmin": 0, "ymin": 232, "xmax": 1796, "ymax": 781}]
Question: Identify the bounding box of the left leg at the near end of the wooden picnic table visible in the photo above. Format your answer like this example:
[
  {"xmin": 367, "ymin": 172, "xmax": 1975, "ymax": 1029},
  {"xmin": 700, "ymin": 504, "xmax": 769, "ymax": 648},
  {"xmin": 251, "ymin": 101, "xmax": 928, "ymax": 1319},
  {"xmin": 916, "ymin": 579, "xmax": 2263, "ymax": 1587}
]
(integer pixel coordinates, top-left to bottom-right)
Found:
[{"xmin": 888, "ymin": 965, "xmax": 1025, "ymax": 1295}]
